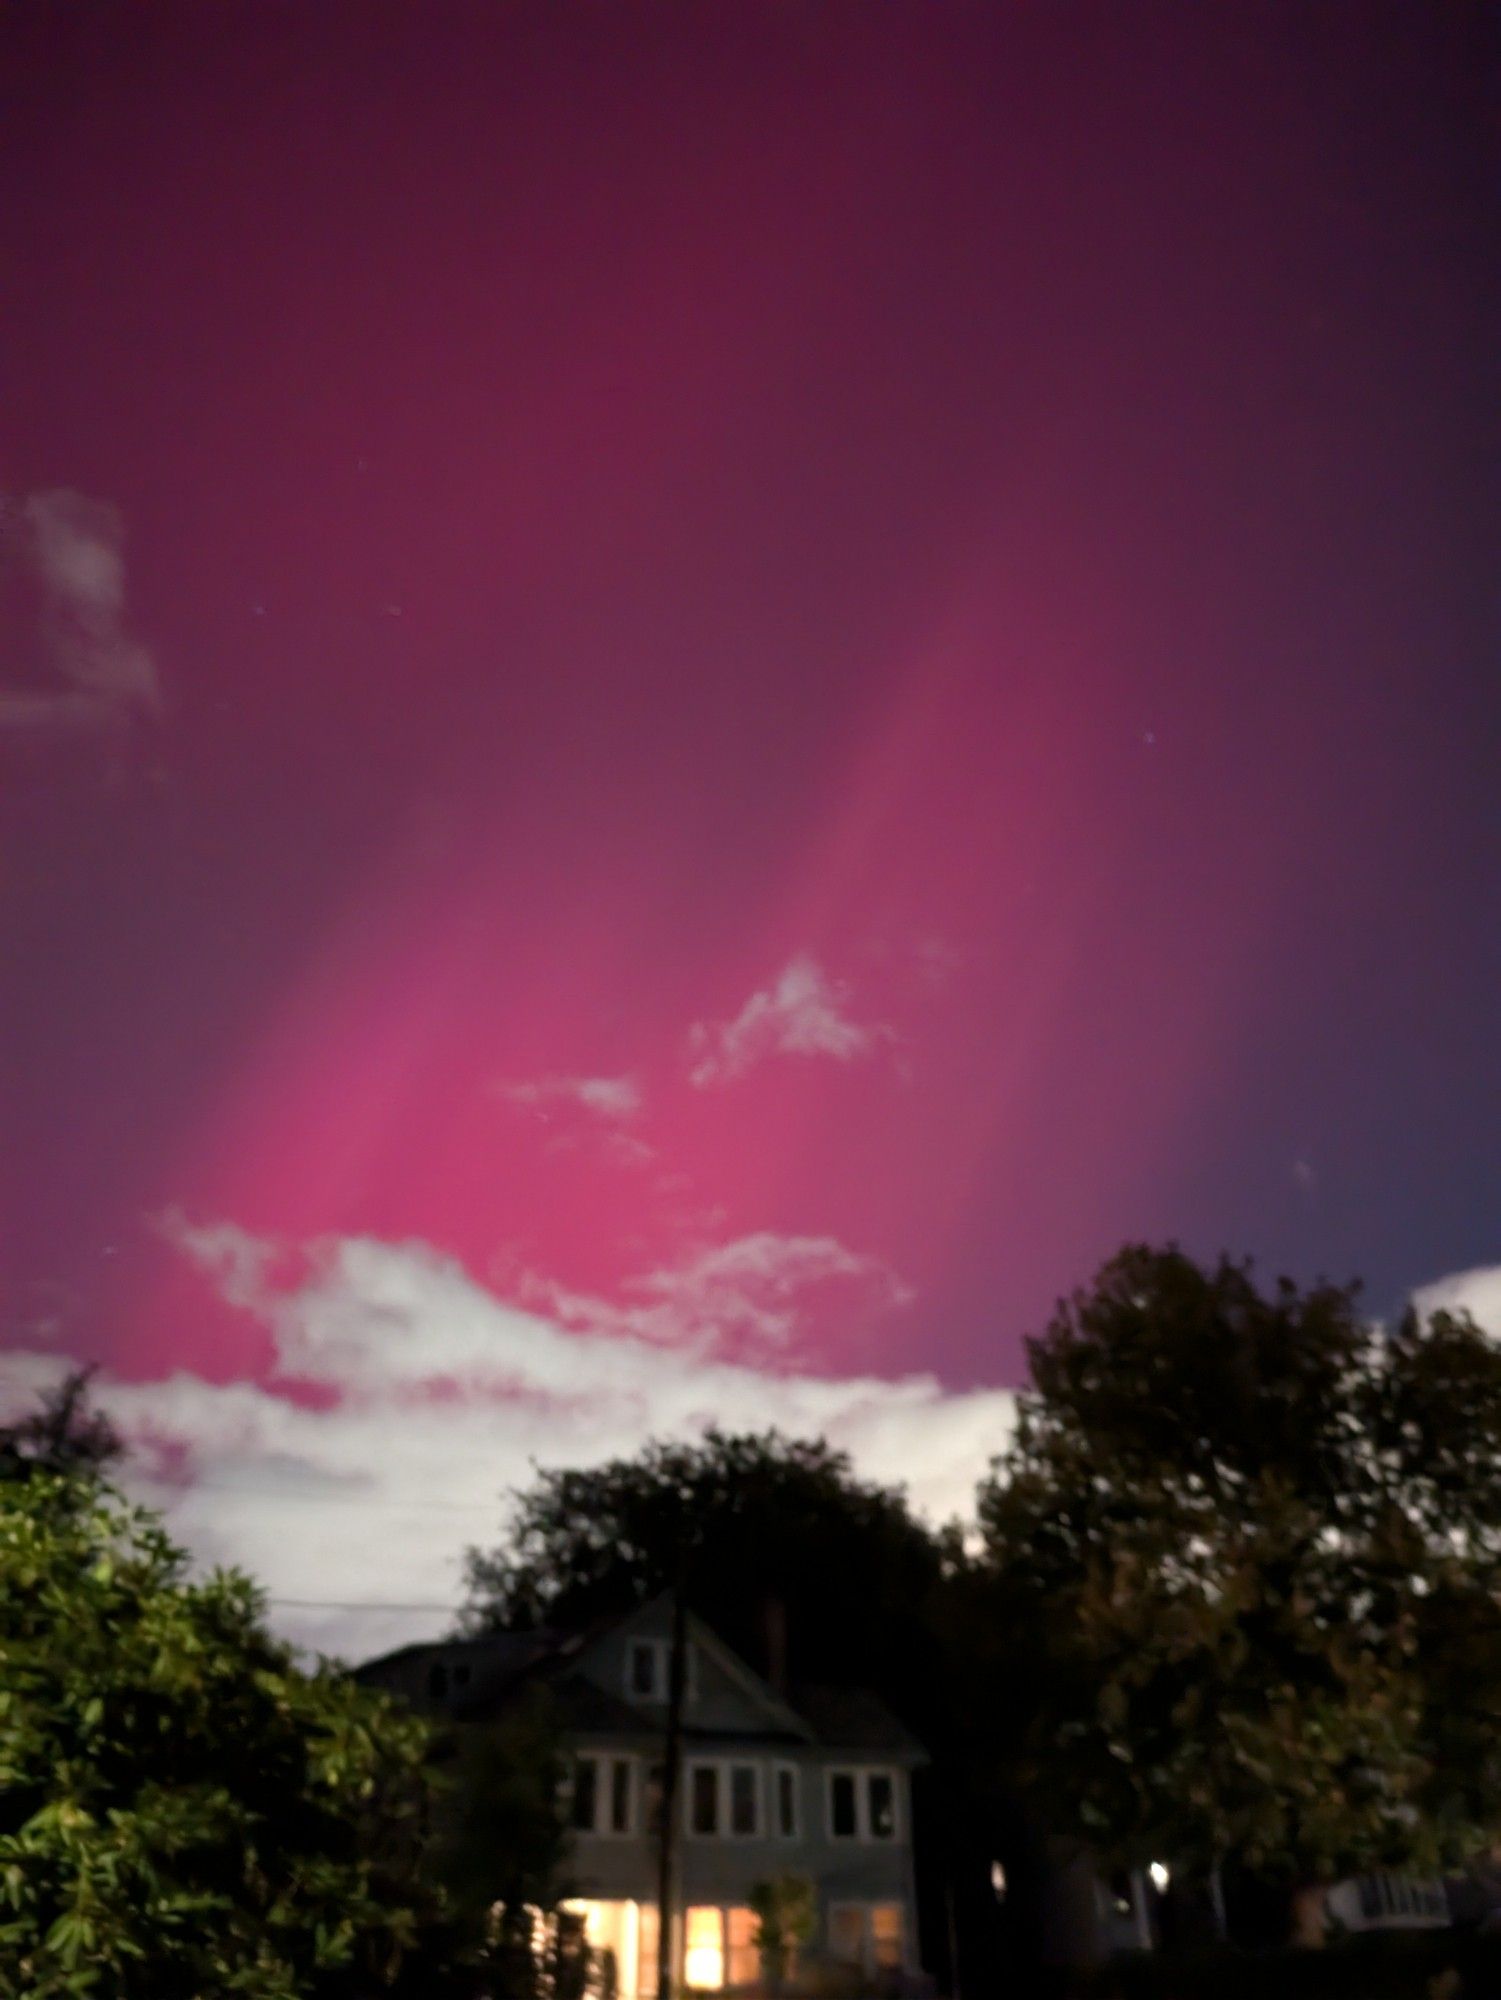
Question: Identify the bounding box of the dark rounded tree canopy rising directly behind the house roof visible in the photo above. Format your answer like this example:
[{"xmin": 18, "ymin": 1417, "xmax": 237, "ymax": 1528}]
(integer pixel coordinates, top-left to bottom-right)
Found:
[{"xmin": 466, "ymin": 1430, "xmax": 943, "ymax": 1698}]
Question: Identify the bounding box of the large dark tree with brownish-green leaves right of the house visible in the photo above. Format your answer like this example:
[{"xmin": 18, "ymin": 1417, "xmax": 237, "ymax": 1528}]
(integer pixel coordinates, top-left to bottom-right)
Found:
[{"xmin": 981, "ymin": 1248, "xmax": 1501, "ymax": 1880}]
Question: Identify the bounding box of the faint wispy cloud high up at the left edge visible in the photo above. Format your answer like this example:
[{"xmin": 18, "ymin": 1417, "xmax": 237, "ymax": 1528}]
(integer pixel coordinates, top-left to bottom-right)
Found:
[{"xmin": 0, "ymin": 486, "xmax": 162, "ymax": 730}]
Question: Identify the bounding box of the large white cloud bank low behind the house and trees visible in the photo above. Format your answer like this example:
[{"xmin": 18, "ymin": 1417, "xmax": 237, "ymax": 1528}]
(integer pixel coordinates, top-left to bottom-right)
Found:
[{"xmin": 0, "ymin": 1226, "xmax": 1013, "ymax": 1656}]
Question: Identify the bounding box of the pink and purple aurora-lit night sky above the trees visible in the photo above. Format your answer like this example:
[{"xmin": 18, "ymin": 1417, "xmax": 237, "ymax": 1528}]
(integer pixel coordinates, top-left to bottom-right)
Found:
[{"xmin": 0, "ymin": 0, "xmax": 1501, "ymax": 1640}]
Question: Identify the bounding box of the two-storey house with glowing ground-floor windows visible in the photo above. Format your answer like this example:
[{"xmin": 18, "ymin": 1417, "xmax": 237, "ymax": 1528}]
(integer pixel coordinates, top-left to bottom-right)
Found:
[{"xmin": 356, "ymin": 1598, "xmax": 925, "ymax": 2000}]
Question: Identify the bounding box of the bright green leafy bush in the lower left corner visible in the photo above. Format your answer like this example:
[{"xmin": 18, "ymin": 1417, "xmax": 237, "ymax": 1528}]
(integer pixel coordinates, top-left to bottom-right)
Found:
[{"xmin": 0, "ymin": 1472, "xmax": 452, "ymax": 2000}]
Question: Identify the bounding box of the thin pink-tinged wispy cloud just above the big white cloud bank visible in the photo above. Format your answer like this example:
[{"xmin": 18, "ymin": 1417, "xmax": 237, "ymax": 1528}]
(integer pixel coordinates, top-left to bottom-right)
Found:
[{"xmin": 524, "ymin": 1230, "xmax": 913, "ymax": 1354}]
